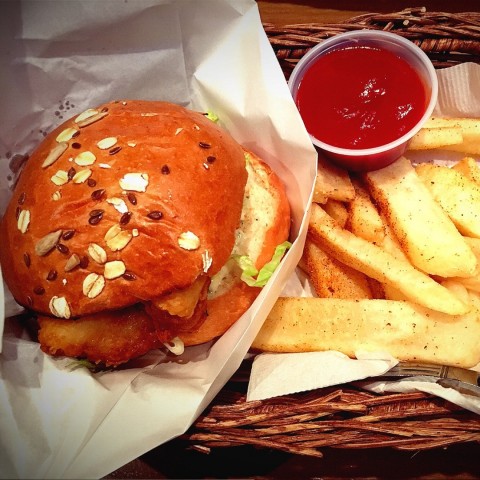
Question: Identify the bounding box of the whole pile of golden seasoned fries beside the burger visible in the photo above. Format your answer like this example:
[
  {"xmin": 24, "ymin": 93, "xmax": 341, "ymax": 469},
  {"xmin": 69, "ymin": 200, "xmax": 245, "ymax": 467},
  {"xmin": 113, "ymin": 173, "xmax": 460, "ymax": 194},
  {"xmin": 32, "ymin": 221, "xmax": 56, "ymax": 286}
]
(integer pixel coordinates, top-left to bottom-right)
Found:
[{"xmin": 252, "ymin": 118, "xmax": 480, "ymax": 368}]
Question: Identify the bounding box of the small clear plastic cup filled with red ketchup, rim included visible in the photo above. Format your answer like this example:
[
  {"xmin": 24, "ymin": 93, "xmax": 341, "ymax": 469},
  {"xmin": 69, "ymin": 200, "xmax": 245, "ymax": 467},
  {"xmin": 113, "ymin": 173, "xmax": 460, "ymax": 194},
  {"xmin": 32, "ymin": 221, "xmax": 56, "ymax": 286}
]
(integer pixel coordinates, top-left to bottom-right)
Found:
[{"xmin": 288, "ymin": 30, "xmax": 438, "ymax": 171}]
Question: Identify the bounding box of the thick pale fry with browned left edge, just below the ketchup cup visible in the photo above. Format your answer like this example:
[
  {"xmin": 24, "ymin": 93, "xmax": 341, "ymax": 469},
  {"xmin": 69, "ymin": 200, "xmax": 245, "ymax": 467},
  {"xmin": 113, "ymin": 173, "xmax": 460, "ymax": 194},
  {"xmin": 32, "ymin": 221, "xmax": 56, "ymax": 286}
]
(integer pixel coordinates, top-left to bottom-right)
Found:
[{"xmin": 365, "ymin": 157, "xmax": 477, "ymax": 277}]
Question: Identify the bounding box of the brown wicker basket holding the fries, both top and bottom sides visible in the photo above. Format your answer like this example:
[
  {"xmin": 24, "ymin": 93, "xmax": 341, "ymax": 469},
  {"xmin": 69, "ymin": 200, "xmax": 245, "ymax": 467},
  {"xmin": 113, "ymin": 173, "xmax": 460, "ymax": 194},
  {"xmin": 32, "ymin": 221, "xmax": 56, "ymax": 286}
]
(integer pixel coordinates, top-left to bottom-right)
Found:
[{"xmin": 183, "ymin": 8, "xmax": 480, "ymax": 457}]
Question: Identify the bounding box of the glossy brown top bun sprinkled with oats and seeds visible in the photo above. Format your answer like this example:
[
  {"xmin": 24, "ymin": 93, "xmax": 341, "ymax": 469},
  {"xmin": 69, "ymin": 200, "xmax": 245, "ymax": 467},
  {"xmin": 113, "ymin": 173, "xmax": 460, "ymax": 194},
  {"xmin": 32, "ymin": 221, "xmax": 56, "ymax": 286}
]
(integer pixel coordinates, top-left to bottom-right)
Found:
[{"xmin": 0, "ymin": 100, "xmax": 247, "ymax": 318}]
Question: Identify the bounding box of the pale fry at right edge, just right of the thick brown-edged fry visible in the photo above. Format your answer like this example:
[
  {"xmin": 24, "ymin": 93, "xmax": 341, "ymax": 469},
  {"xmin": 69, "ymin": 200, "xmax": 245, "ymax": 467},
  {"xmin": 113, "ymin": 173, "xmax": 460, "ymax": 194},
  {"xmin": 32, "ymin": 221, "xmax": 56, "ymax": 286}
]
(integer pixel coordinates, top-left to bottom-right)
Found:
[{"xmin": 416, "ymin": 163, "xmax": 480, "ymax": 238}]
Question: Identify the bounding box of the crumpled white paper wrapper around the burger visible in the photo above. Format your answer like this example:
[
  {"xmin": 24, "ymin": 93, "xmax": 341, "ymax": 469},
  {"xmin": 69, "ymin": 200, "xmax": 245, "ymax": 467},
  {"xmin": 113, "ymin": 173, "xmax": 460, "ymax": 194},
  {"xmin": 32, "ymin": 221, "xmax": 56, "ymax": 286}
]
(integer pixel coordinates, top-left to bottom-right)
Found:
[{"xmin": 0, "ymin": 0, "xmax": 316, "ymax": 478}]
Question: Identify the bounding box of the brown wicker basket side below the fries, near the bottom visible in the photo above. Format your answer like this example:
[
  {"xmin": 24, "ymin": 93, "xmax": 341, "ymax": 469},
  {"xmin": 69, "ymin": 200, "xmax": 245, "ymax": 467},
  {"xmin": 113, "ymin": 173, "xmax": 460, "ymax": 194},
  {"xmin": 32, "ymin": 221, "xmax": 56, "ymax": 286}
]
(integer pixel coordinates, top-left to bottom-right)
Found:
[{"xmin": 184, "ymin": 366, "xmax": 480, "ymax": 457}]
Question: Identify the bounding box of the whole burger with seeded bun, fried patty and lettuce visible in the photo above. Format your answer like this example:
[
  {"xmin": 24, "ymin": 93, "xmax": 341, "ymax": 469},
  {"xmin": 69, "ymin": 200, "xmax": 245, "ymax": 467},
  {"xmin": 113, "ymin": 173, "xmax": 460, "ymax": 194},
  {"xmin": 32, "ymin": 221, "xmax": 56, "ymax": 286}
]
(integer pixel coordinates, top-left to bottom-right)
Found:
[{"xmin": 0, "ymin": 100, "xmax": 290, "ymax": 366}]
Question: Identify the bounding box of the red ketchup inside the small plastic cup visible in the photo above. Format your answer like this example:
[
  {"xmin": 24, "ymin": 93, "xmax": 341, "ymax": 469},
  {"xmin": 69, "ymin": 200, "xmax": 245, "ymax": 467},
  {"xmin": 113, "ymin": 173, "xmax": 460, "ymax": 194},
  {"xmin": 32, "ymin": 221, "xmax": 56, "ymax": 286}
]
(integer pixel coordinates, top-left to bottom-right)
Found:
[{"xmin": 296, "ymin": 46, "xmax": 428, "ymax": 149}]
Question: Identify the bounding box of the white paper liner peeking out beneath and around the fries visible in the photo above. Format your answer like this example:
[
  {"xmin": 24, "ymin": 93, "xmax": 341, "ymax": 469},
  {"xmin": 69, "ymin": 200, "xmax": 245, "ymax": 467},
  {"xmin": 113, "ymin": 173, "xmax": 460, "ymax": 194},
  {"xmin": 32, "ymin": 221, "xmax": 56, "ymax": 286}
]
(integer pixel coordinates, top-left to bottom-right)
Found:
[{"xmin": 247, "ymin": 63, "xmax": 480, "ymax": 413}]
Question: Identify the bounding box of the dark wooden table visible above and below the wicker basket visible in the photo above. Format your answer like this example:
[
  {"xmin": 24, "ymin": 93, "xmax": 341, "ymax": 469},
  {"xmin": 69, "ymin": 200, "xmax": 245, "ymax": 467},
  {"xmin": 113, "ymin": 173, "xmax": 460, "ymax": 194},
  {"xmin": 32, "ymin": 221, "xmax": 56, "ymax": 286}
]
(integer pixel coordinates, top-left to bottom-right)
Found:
[{"xmin": 106, "ymin": 0, "xmax": 480, "ymax": 480}]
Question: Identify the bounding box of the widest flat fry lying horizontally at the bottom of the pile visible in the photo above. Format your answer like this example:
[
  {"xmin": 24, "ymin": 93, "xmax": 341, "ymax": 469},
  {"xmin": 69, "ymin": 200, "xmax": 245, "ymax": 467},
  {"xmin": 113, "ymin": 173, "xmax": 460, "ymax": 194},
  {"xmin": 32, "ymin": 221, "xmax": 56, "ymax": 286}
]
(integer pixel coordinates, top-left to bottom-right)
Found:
[{"xmin": 252, "ymin": 298, "xmax": 480, "ymax": 368}]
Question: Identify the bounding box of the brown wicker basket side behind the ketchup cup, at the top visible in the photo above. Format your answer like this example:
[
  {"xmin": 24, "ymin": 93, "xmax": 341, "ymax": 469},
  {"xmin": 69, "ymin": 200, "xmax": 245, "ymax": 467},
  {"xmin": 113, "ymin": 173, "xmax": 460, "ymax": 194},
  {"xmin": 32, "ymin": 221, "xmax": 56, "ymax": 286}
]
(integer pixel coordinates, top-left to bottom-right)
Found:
[{"xmin": 264, "ymin": 7, "xmax": 480, "ymax": 79}]
